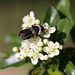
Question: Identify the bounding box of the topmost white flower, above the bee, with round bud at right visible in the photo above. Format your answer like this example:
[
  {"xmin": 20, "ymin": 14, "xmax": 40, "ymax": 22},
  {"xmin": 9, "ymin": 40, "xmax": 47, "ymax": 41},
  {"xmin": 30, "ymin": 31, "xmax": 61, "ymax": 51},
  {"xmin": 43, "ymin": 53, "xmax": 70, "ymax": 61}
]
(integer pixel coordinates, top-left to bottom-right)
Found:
[{"xmin": 22, "ymin": 11, "xmax": 40, "ymax": 29}]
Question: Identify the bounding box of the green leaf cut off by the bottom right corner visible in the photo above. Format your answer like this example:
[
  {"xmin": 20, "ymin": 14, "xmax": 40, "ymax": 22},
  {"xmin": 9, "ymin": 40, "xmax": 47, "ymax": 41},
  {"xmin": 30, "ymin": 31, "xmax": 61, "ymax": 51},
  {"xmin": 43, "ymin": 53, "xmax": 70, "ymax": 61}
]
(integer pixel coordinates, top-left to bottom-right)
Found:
[{"xmin": 65, "ymin": 61, "xmax": 75, "ymax": 75}]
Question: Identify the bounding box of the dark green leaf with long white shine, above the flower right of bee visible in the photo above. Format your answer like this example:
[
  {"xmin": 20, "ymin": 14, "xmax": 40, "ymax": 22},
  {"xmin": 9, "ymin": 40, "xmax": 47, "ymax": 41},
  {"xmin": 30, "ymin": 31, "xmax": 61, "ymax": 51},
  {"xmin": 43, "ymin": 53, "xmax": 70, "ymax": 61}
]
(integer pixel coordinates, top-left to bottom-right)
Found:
[{"xmin": 43, "ymin": 7, "xmax": 59, "ymax": 26}]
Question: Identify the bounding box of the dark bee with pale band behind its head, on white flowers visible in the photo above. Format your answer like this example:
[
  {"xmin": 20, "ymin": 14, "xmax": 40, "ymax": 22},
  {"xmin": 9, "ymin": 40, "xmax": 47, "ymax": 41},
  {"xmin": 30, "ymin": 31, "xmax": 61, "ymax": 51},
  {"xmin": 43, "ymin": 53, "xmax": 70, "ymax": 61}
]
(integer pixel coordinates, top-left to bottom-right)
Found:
[{"xmin": 18, "ymin": 25, "xmax": 44, "ymax": 40}]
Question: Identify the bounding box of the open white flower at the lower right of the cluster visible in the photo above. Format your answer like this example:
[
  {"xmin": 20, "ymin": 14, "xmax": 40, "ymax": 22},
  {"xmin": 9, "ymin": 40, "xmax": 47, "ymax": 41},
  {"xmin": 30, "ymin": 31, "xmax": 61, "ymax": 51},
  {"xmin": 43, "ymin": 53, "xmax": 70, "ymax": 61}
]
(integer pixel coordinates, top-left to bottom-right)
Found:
[{"xmin": 43, "ymin": 41, "xmax": 59, "ymax": 58}]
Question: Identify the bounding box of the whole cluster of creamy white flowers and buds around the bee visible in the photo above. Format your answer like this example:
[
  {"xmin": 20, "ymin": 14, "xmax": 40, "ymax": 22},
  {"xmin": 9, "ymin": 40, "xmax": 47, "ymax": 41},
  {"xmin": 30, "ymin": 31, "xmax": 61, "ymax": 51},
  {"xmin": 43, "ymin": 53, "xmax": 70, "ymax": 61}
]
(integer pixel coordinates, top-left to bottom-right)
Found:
[{"xmin": 13, "ymin": 11, "xmax": 60, "ymax": 65}]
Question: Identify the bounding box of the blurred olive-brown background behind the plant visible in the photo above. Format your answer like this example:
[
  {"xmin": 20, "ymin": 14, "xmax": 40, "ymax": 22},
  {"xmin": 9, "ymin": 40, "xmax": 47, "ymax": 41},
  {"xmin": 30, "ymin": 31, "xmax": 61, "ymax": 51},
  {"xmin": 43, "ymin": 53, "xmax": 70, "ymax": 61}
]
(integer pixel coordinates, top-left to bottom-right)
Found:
[{"xmin": 0, "ymin": 0, "xmax": 75, "ymax": 75}]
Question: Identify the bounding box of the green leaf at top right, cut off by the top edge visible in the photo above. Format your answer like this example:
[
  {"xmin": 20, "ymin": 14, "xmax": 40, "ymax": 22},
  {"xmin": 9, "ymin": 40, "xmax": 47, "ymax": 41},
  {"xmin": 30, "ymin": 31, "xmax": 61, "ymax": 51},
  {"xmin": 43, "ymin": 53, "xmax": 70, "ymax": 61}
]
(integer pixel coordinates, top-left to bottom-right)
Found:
[{"xmin": 57, "ymin": 0, "xmax": 75, "ymax": 26}]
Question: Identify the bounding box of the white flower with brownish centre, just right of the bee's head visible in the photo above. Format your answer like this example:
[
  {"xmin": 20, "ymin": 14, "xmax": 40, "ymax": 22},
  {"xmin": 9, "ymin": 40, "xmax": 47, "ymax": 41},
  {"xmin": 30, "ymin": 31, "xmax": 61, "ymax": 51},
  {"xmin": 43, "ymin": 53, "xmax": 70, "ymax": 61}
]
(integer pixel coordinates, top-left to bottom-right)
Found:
[{"xmin": 43, "ymin": 23, "xmax": 56, "ymax": 38}]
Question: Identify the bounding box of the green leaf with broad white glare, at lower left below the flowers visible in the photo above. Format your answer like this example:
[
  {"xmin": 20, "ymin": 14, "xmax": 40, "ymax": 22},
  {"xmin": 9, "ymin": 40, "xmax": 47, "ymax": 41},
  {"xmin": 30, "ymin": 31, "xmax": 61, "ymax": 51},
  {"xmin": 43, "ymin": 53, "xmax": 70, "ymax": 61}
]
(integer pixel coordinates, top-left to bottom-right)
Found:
[{"xmin": 0, "ymin": 54, "xmax": 27, "ymax": 69}]
